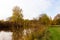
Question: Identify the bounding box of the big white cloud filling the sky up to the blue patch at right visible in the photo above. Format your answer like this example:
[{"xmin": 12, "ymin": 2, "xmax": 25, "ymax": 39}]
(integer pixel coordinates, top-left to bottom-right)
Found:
[{"xmin": 0, "ymin": 0, "xmax": 51, "ymax": 19}]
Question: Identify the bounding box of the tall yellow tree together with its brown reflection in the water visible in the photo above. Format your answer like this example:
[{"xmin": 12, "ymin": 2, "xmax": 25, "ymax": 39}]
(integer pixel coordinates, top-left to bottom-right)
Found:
[{"xmin": 8, "ymin": 6, "xmax": 23, "ymax": 40}]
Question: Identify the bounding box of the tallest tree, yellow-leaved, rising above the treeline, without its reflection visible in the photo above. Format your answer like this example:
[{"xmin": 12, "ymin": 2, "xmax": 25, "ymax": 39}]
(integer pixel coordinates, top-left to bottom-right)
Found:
[{"xmin": 8, "ymin": 6, "xmax": 23, "ymax": 22}]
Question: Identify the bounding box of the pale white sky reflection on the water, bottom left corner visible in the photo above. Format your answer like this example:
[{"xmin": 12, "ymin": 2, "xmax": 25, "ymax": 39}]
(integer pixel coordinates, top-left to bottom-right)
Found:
[{"xmin": 0, "ymin": 31, "xmax": 12, "ymax": 40}]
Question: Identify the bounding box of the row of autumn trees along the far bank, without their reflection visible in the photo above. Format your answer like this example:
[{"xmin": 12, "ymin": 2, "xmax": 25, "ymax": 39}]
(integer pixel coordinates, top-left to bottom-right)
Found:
[{"xmin": 0, "ymin": 6, "xmax": 60, "ymax": 28}]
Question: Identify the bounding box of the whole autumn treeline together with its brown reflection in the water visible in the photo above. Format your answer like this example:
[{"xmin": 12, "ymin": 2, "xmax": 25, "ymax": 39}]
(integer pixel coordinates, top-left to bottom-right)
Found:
[{"xmin": 0, "ymin": 6, "xmax": 60, "ymax": 40}]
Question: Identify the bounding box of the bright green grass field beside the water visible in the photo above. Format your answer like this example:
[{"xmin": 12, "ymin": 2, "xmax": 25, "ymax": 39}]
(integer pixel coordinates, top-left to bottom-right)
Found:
[{"xmin": 48, "ymin": 27, "xmax": 60, "ymax": 40}]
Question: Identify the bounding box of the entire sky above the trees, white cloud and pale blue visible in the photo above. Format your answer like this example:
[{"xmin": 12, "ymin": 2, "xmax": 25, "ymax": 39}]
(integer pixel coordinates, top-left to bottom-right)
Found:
[{"xmin": 0, "ymin": 0, "xmax": 60, "ymax": 19}]
